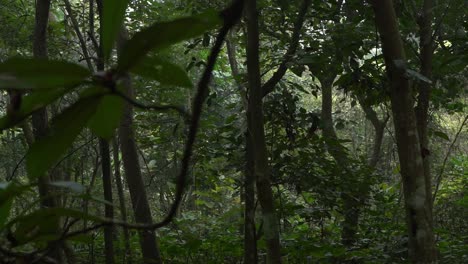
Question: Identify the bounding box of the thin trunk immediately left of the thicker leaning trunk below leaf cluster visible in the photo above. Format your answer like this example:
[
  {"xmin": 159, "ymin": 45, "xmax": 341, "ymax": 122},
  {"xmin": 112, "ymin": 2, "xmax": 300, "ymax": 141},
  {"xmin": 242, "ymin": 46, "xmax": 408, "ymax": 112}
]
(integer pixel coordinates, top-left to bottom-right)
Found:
[{"xmin": 112, "ymin": 139, "xmax": 133, "ymax": 264}]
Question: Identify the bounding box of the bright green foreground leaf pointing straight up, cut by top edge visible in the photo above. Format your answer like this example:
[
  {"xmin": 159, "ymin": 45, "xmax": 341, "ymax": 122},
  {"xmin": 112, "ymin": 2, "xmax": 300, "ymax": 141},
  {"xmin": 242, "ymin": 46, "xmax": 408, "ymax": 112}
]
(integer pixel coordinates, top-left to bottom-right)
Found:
[{"xmin": 101, "ymin": 0, "xmax": 129, "ymax": 60}]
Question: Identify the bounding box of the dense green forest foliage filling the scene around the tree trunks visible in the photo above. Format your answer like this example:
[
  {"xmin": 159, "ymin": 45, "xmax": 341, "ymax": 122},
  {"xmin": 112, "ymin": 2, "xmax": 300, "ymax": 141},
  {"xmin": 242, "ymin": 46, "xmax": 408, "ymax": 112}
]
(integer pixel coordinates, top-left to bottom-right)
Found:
[{"xmin": 0, "ymin": 0, "xmax": 468, "ymax": 263}]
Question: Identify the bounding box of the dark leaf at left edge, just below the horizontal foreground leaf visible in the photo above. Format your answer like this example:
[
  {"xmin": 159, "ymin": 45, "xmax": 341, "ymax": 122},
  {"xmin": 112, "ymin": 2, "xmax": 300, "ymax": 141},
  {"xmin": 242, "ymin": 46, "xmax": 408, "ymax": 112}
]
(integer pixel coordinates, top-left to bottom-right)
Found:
[{"xmin": 0, "ymin": 89, "xmax": 66, "ymax": 131}]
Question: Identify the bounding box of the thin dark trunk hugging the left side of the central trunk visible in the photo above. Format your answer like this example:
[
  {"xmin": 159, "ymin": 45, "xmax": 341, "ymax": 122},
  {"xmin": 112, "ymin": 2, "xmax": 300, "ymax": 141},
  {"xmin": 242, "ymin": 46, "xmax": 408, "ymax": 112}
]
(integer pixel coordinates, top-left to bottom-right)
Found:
[{"xmin": 226, "ymin": 33, "xmax": 258, "ymax": 264}]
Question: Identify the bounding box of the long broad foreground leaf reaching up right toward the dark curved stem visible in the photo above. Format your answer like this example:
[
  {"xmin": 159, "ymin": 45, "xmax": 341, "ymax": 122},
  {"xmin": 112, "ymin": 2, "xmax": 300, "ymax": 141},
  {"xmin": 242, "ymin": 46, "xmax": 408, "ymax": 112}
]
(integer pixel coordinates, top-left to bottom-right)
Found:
[{"xmin": 117, "ymin": 11, "xmax": 221, "ymax": 72}]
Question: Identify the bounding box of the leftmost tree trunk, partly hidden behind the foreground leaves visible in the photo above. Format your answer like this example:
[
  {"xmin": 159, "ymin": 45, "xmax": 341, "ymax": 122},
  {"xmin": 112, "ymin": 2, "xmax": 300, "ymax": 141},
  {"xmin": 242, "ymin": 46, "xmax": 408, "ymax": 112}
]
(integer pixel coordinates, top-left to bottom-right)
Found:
[{"xmin": 32, "ymin": 0, "xmax": 62, "ymax": 262}]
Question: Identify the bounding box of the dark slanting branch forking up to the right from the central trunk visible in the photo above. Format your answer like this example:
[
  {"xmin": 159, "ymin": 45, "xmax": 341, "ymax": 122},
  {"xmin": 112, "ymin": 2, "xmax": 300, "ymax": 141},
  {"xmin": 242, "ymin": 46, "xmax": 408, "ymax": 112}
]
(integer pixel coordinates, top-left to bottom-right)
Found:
[{"xmin": 262, "ymin": 0, "xmax": 312, "ymax": 96}]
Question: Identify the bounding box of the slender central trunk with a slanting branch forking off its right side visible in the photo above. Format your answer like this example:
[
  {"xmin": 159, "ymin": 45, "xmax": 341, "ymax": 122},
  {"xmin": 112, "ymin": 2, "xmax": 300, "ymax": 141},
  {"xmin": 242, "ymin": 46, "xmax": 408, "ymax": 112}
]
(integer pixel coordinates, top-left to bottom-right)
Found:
[{"xmin": 246, "ymin": 0, "xmax": 281, "ymax": 264}]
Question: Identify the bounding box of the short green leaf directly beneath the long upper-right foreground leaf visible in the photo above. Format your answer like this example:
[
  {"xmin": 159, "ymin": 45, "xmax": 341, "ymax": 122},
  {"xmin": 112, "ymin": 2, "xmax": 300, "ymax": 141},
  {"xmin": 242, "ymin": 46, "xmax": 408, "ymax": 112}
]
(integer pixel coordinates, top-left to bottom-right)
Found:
[{"xmin": 132, "ymin": 56, "xmax": 193, "ymax": 88}]
